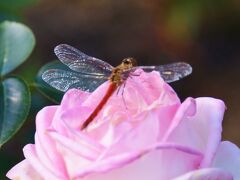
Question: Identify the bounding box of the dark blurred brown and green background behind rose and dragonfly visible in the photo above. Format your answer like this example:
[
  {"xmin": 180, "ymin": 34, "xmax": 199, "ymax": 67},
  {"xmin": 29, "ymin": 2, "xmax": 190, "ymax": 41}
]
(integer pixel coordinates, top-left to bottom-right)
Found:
[{"xmin": 0, "ymin": 0, "xmax": 240, "ymax": 179}]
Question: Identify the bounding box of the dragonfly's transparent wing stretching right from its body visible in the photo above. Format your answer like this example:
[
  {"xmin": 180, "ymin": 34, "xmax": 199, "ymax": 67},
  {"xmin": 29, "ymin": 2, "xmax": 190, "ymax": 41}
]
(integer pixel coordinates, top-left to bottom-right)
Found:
[{"xmin": 123, "ymin": 62, "xmax": 192, "ymax": 83}]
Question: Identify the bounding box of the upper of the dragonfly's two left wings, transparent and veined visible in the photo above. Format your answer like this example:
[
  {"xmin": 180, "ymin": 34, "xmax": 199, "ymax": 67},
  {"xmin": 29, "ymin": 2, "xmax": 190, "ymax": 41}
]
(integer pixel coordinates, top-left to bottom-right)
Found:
[{"xmin": 54, "ymin": 44, "xmax": 113, "ymax": 76}]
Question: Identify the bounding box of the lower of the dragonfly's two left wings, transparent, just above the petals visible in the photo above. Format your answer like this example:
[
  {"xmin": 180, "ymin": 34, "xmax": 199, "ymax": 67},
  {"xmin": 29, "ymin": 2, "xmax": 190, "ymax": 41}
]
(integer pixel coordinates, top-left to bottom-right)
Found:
[{"xmin": 42, "ymin": 69, "xmax": 108, "ymax": 92}]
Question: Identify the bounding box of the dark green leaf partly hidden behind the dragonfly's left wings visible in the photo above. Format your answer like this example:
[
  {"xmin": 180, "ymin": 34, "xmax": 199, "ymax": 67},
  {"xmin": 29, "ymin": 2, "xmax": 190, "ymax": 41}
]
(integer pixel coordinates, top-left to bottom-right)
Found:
[{"xmin": 36, "ymin": 61, "xmax": 64, "ymax": 103}]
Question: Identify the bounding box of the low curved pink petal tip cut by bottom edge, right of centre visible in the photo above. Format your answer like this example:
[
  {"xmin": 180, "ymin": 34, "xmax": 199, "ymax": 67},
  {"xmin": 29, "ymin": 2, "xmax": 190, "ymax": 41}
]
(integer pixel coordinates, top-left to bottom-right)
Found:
[{"xmin": 174, "ymin": 168, "xmax": 233, "ymax": 180}]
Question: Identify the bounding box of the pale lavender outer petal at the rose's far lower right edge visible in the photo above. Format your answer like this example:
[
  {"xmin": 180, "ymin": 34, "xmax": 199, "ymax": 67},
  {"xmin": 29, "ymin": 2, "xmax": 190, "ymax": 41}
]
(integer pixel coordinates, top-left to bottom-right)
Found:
[{"xmin": 211, "ymin": 141, "xmax": 240, "ymax": 179}]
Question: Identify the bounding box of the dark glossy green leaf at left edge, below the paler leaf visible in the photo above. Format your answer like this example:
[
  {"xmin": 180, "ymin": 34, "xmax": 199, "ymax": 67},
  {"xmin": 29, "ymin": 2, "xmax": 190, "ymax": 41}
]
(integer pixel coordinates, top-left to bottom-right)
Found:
[{"xmin": 0, "ymin": 77, "xmax": 30, "ymax": 147}]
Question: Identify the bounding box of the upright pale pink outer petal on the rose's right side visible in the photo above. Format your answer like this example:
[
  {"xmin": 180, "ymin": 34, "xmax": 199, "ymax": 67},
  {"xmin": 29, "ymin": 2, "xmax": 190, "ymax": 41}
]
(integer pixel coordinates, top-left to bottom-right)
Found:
[{"xmin": 163, "ymin": 98, "xmax": 225, "ymax": 167}]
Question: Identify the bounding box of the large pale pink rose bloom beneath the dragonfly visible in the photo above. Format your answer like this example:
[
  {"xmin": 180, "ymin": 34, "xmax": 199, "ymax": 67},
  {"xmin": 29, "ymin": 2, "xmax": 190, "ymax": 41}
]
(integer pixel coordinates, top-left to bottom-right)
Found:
[{"xmin": 7, "ymin": 70, "xmax": 240, "ymax": 180}]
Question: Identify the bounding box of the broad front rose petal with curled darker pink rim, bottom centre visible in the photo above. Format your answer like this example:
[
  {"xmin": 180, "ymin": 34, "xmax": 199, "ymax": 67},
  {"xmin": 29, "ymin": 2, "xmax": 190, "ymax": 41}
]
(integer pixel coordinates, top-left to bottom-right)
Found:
[{"xmin": 73, "ymin": 144, "xmax": 202, "ymax": 180}]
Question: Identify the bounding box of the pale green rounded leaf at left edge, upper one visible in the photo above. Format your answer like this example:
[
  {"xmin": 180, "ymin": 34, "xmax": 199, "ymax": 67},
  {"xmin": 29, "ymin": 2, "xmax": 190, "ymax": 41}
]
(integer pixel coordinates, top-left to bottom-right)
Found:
[{"xmin": 0, "ymin": 21, "xmax": 35, "ymax": 76}]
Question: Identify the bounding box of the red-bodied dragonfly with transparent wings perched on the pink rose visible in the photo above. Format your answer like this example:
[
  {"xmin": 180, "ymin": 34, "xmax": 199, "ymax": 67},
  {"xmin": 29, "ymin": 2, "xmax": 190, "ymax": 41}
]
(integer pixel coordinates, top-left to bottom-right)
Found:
[{"xmin": 42, "ymin": 44, "xmax": 192, "ymax": 130}]
